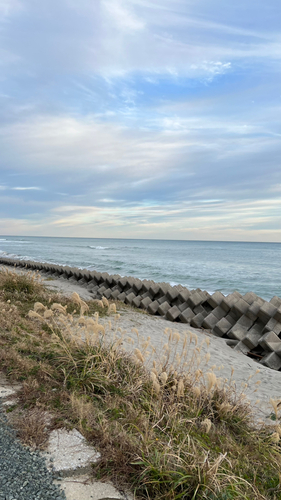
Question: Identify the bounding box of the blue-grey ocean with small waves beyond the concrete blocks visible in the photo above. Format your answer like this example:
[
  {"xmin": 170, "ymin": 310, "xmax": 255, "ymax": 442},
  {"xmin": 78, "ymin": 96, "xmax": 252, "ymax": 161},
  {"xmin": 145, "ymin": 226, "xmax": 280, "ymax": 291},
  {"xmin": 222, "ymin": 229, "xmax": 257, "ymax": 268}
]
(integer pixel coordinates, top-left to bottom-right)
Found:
[{"xmin": 0, "ymin": 236, "xmax": 281, "ymax": 300}]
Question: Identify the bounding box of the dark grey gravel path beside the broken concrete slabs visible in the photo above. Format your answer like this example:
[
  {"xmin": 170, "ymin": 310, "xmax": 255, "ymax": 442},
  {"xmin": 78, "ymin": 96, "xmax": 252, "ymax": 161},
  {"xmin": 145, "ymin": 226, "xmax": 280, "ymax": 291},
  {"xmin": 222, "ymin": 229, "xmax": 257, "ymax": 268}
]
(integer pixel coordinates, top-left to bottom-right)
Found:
[{"xmin": 0, "ymin": 402, "xmax": 65, "ymax": 500}]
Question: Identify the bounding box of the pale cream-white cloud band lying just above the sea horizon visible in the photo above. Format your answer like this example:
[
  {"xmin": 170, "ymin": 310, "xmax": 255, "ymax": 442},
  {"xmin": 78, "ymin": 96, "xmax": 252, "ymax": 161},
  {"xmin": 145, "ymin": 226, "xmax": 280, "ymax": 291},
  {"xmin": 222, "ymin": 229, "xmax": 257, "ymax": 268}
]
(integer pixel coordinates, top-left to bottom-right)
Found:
[{"xmin": 0, "ymin": 195, "xmax": 281, "ymax": 241}]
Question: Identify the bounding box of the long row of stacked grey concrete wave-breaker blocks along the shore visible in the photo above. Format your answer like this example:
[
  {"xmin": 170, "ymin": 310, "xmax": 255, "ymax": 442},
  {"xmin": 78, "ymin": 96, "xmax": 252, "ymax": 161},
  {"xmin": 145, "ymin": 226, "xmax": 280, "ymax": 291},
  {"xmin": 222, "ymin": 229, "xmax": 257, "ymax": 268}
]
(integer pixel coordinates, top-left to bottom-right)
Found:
[{"xmin": 0, "ymin": 257, "xmax": 281, "ymax": 370}]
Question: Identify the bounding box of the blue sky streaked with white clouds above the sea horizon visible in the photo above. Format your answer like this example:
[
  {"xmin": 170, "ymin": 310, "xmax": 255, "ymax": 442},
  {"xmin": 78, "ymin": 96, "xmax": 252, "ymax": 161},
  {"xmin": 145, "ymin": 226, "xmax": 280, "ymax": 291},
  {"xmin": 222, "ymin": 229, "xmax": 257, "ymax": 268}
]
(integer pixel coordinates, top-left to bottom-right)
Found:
[{"xmin": 0, "ymin": 0, "xmax": 281, "ymax": 242}]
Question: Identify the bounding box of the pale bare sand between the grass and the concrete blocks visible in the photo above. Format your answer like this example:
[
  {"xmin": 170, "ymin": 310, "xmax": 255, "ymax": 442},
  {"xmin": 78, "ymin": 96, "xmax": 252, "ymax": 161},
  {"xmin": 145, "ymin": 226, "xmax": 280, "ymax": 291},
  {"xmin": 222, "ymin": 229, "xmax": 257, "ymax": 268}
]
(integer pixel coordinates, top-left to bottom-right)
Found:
[{"xmin": 4, "ymin": 270, "xmax": 281, "ymax": 423}]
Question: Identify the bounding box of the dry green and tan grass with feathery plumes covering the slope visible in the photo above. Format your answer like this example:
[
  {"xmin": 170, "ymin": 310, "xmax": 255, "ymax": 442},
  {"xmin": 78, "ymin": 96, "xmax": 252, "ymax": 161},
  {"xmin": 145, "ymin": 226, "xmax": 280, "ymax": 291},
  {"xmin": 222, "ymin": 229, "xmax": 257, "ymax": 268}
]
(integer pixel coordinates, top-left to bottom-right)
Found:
[{"xmin": 0, "ymin": 271, "xmax": 281, "ymax": 500}]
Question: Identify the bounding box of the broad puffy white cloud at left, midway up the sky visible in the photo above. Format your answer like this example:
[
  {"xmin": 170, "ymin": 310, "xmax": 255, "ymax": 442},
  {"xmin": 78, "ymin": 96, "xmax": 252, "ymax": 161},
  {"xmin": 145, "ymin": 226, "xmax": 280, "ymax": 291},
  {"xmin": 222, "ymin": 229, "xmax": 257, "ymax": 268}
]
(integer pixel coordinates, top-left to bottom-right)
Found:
[{"xmin": 0, "ymin": 116, "xmax": 190, "ymax": 179}]
